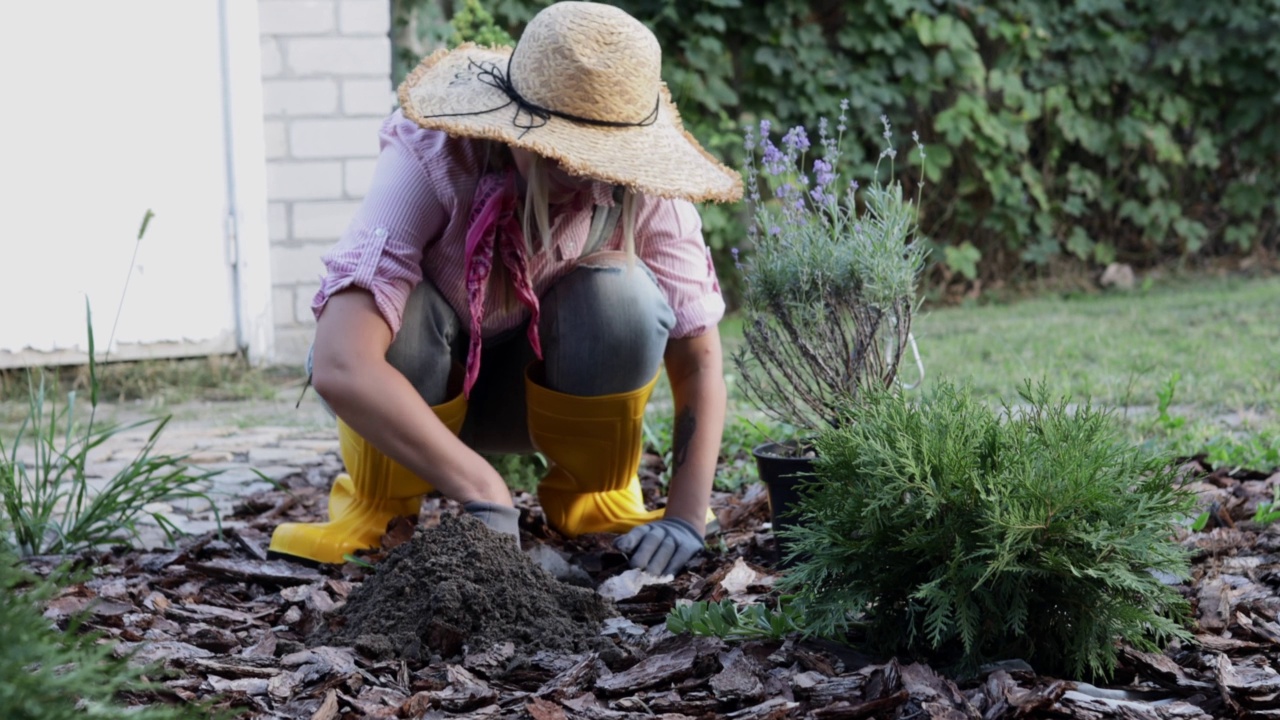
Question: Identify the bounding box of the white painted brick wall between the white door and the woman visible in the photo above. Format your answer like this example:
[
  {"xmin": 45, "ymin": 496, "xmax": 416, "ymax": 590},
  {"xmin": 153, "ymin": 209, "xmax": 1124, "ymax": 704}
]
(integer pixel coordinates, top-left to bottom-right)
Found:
[{"xmin": 257, "ymin": 0, "xmax": 394, "ymax": 364}]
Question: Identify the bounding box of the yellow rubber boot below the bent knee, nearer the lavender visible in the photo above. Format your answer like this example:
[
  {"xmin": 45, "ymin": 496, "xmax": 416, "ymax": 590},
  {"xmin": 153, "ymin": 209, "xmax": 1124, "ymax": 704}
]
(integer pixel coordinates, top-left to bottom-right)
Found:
[{"xmin": 525, "ymin": 375, "xmax": 663, "ymax": 537}]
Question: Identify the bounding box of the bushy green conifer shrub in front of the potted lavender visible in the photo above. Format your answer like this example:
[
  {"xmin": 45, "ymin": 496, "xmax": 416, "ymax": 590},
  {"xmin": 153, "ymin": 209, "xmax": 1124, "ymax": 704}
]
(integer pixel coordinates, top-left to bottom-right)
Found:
[{"xmin": 783, "ymin": 382, "xmax": 1193, "ymax": 678}]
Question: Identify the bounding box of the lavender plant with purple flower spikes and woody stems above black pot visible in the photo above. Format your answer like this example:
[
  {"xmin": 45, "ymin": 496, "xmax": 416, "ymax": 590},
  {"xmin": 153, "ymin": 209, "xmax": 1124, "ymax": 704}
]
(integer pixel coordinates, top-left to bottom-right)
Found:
[{"xmin": 733, "ymin": 106, "xmax": 925, "ymax": 429}]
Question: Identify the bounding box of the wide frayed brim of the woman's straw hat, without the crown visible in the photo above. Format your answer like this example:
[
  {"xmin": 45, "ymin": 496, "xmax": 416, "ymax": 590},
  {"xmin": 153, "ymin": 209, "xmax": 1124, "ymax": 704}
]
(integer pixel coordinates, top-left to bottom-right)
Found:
[{"xmin": 399, "ymin": 44, "xmax": 742, "ymax": 202}]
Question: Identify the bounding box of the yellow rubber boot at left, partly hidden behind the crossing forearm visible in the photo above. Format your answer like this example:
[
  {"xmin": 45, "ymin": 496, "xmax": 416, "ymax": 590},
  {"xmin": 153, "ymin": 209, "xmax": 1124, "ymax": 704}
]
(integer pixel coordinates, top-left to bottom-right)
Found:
[{"xmin": 270, "ymin": 395, "xmax": 467, "ymax": 562}]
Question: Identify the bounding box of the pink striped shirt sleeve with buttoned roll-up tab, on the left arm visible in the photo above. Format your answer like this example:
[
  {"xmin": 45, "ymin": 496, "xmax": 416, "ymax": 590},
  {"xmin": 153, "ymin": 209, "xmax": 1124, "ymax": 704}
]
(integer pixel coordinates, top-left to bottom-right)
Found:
[{"xmin": 311, "ymin": 111, "xmax": 453, "ymax": 336}]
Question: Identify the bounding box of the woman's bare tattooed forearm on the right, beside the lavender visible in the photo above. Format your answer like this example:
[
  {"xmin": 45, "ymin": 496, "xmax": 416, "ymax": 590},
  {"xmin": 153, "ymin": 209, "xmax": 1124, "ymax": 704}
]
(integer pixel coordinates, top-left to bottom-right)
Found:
[{"xmin": 664, "ymin": 328, "xmax": 727, "ymax": 533}]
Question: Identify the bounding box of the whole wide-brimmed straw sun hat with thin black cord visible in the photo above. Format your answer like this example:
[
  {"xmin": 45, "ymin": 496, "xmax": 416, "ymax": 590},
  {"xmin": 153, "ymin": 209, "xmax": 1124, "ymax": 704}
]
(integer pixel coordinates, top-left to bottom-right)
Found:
[{"xmin": 399, "ymin": 1, "xmax": 742, "ymax": 202}]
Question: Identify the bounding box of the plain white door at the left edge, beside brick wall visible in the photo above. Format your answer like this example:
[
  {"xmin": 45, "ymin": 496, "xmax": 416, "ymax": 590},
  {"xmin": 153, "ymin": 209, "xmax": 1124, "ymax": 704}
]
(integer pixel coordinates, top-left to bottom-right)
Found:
[{"xmin": 0, "ymin": 0, "xmax": 237, "ymax": 368}]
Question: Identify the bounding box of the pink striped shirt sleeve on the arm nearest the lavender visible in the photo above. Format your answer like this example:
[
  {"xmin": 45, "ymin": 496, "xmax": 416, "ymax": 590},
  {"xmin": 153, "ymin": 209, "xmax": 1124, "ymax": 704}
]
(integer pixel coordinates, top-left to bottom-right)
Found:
[{"xmin": 636, "ymin": 197, "xmax": 724, "ymax": 338}]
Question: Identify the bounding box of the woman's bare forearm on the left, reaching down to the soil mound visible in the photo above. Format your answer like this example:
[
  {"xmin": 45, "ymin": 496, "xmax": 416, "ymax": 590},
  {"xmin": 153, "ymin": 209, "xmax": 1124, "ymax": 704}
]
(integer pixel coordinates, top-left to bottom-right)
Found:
[{"xmin": 311, "ymin": 290, "xmax": 511, "ymax": 506}]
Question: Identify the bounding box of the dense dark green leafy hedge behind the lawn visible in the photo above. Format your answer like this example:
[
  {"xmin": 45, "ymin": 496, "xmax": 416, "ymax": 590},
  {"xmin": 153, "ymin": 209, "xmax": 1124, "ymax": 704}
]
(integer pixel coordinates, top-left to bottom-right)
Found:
[{"xmin": 402, "ymin": 0, "xmax": 1280, "ymax": 295}]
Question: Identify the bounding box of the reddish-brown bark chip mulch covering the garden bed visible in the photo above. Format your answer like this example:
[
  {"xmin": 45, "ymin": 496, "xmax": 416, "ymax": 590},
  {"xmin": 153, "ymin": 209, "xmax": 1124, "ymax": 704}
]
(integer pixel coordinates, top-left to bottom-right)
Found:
[{"xmin": 33, "ymin": 450, "xmax": 1280, "ymax": 720}]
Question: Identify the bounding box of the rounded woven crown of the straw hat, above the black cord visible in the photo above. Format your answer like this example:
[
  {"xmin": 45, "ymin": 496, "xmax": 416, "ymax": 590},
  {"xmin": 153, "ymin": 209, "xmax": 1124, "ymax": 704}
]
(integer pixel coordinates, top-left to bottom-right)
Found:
[{"xmin": 509, "ymin": 1, "xmax": 662, "ymax": 123}]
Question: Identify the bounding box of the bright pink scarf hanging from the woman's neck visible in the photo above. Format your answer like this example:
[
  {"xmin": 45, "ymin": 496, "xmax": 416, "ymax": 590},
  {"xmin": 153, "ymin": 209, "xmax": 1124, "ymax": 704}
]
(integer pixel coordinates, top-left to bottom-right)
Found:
[{"xmin": 462, "ymin": 170, "xmax": 543, "ymax": 397}]
